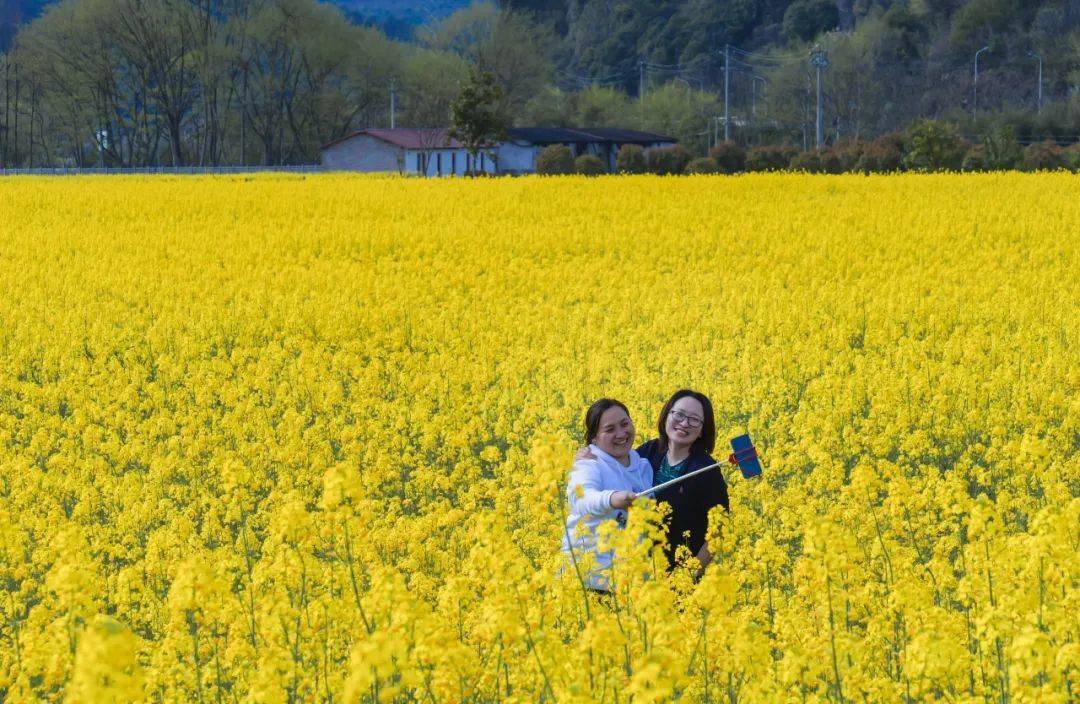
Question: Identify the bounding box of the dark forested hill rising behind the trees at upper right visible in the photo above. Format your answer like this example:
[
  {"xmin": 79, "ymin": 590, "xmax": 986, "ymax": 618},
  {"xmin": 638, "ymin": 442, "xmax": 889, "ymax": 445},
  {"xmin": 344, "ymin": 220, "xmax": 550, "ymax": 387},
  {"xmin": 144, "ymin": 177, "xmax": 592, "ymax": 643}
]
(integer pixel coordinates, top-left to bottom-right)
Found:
[{"xmin": 516, "ymin": 0, "xmax": 1080, "ymax": 77}]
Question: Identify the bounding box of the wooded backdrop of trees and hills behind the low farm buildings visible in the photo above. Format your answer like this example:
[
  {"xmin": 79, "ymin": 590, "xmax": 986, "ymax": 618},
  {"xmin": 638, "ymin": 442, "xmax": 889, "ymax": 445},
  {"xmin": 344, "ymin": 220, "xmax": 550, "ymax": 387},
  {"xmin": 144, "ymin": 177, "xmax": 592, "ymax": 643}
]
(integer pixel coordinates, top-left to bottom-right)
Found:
[{"xmin": 0, "ymin": 0, "xmax": 1080, "ymax": 165}]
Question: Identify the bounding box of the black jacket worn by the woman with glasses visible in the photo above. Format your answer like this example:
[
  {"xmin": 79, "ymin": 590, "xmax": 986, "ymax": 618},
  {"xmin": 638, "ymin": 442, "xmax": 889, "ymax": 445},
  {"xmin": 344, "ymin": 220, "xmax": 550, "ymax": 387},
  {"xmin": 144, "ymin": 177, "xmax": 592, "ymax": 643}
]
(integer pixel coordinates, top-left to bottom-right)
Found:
[{"xmin": 637, "ymin": 439, "xmax": 728, "ymax": 565}]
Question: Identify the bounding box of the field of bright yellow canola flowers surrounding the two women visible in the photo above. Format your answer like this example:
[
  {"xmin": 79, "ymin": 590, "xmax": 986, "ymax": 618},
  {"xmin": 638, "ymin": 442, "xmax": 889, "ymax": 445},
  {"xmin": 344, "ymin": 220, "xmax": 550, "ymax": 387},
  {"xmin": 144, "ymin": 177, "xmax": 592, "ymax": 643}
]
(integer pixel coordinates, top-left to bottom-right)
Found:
[{"xmin": 0, "ymin": 174, "xmax": 1080, "ymax": 704}]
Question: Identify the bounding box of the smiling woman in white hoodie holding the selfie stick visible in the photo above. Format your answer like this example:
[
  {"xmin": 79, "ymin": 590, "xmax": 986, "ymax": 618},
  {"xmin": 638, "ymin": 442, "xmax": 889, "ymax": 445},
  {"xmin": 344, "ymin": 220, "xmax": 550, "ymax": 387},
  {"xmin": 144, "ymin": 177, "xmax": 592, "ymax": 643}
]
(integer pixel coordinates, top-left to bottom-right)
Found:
[{"xmin": 563, "ymin": 398, "xmax": 652, "ymax": 592}]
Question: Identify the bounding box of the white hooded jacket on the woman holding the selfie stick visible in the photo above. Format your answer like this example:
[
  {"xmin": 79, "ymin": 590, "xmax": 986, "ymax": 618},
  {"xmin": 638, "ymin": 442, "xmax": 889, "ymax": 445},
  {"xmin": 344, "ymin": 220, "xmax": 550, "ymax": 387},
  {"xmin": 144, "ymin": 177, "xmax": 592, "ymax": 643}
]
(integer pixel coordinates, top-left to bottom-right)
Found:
[{"xmin": 563, "ymin": 445, "xmax": 652, "ymax": 591}]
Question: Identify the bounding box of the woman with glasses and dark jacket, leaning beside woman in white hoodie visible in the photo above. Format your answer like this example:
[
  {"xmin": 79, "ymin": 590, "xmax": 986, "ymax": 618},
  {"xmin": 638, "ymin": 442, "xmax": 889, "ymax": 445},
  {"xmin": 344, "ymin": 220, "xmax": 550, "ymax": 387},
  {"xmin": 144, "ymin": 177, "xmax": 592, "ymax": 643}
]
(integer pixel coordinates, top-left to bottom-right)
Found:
[{"xmin": 578, "ymin": 389, "xmax": 728, "ymax": 569}]
